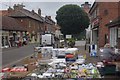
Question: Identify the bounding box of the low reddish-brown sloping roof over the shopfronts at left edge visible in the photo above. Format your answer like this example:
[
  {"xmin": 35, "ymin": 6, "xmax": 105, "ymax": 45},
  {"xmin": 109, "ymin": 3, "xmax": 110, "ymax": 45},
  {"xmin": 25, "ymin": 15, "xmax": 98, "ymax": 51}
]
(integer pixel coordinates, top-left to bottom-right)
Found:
[{"xmin": 0, "ymin": 16, "xmax": 26, "ymax": 31}]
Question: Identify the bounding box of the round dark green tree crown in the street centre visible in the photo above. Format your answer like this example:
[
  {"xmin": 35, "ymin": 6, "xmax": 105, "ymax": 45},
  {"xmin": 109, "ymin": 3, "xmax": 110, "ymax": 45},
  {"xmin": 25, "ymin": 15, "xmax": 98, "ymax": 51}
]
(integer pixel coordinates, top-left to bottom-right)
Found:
[{"xmin": 56, "ymin": 4, "xmax": 89, "ymax": 35}]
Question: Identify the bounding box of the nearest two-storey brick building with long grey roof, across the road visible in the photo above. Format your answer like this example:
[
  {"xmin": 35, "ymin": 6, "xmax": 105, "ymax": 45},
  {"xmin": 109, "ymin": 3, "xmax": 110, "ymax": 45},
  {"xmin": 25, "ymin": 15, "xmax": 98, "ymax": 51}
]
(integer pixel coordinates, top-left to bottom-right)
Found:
[{"xmin": 8, "ymin": 4, "xmax": 44, "ymax": 43}]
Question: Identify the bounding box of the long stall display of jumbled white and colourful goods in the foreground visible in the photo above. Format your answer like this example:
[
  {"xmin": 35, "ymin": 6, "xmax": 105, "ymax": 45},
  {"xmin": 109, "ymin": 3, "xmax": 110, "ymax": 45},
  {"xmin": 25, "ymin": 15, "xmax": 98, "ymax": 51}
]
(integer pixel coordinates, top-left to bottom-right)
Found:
[{"xmin": 26, "ymin": 48, "xmax": 101, "ymax": 78}]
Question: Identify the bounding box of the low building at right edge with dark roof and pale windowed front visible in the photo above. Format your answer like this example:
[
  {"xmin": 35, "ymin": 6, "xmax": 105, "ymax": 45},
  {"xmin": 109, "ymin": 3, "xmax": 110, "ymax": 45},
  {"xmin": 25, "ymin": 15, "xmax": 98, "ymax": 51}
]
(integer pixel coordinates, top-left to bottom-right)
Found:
[{"xmin": 106, "ymin": 16, "xmax": 120, "ymax": 49}]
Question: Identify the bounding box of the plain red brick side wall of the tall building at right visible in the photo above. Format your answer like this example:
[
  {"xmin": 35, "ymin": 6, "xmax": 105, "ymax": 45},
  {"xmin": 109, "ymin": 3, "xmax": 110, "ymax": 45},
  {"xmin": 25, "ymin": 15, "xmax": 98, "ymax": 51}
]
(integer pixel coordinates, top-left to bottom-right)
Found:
[{"xmin": 98, "ymin": 2, "xmax": 118, "ymax": 47}]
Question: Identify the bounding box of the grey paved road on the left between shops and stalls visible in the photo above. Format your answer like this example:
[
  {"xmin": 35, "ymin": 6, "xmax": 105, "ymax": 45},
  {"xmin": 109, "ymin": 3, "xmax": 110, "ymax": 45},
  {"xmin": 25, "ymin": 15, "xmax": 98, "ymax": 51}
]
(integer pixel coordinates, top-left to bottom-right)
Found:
[{"xmin": 2, "ymin": 44, "xmax": 36, "ymax": 67}]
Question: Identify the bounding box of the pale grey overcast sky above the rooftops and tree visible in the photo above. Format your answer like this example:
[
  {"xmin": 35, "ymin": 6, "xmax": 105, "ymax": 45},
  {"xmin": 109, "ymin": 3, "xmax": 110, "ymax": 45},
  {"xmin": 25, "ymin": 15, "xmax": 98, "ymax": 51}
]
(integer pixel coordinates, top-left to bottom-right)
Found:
[{"xmin": 0, "ymin": 0, "xmax": 94, "ymax": 21}]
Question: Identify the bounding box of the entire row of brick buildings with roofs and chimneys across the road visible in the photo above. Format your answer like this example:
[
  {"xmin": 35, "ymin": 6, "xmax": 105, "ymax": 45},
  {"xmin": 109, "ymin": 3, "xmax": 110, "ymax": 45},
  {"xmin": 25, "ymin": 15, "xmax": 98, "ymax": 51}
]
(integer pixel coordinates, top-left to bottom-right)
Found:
[{"xmin": 0, "ymin": 4, "xmax": 55, "ymax": 42}]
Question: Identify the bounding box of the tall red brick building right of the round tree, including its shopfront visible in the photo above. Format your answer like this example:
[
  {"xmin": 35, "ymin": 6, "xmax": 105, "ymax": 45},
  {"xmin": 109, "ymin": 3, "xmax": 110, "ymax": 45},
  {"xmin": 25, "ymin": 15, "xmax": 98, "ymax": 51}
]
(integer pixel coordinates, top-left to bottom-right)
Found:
[{"xmin": 89, "ymin": 2, "xmax": 118, "ymax": 47}]
